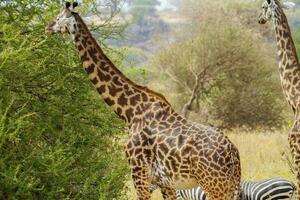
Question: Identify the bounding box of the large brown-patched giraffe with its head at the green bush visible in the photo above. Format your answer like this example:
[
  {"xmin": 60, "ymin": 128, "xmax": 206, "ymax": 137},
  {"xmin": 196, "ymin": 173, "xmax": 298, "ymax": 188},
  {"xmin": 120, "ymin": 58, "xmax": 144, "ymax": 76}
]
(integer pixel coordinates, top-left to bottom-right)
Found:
[{"xmin": 46, "ymin": 2, "xmax": 241, "ymax": 200}]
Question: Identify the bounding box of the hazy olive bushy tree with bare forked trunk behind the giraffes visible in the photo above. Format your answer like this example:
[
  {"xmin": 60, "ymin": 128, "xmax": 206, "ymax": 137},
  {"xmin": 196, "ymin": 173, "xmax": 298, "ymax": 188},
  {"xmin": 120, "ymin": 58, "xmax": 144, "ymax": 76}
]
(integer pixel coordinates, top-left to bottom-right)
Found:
[{"xmin": 154, "ymin": 1, "xmax": 285, "ymax": 128}]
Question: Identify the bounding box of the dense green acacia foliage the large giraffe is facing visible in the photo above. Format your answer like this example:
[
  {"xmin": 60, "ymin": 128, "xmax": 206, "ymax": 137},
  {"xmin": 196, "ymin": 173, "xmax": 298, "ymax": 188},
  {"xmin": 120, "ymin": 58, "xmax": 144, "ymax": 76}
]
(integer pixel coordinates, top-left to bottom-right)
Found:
[{"xmin": 0, "ymin": 0, "xmax": 127, "ymax": 199}]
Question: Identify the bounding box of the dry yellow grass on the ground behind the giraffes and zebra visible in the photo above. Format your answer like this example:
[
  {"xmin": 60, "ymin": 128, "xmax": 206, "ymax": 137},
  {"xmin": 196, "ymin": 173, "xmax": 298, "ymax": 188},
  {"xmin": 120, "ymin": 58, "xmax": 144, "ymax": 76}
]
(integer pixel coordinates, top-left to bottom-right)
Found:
[{"xmin": 126, "ymin": 130, "xmax": 295, "ymax": 200}]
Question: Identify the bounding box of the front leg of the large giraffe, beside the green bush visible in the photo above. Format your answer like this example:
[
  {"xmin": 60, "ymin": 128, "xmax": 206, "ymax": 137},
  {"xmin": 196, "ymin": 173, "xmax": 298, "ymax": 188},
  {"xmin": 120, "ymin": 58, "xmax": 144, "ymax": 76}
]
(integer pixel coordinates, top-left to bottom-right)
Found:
[{"xmin": 131, "ymin": 167, "xmax": 151, "ymax": 200}]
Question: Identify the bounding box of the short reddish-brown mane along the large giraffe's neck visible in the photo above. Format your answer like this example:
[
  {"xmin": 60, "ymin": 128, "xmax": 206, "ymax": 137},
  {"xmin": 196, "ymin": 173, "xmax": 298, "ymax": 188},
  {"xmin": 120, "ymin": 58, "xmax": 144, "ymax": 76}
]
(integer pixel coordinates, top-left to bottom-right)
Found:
[{"xmin": 72, "ymin": 12, "xmax": 170, "ymax": 105}]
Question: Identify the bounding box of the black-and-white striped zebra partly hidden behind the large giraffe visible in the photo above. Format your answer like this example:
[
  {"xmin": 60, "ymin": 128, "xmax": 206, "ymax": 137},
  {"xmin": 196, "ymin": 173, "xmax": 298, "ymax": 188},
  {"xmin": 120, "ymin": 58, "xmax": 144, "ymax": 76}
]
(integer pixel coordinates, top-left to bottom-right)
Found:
[{"xmin": 150, "ymin": 178, "xmax": 296, "ymax": 200}]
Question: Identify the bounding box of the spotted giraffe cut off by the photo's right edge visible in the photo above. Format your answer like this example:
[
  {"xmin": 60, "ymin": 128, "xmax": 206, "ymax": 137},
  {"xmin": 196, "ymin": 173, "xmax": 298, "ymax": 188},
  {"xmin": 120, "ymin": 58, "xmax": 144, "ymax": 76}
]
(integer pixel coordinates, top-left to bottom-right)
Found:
[{"xmin": 258, "ymin": 0, "xmax": 300, "ymax": 200}]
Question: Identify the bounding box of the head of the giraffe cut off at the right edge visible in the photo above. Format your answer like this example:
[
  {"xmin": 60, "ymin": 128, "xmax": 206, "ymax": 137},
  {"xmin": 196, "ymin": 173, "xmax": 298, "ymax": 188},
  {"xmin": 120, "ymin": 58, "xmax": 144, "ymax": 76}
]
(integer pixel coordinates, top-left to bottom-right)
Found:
[{"xmin": 258, "ymin": 0, "xmax": 295, "ymax": 24}]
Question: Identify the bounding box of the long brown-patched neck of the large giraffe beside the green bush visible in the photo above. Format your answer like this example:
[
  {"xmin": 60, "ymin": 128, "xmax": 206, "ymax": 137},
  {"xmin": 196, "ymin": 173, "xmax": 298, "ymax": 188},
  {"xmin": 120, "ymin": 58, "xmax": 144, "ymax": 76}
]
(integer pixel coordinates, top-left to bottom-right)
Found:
[{"xmin": 69, "ymin": 13, "xmax": 169, "ymax": 124}]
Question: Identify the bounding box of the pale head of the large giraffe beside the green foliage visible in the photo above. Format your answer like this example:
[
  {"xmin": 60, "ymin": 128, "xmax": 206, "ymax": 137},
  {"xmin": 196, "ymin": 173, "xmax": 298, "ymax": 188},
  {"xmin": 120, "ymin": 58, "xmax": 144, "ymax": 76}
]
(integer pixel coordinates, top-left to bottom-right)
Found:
[{"xmin": 46, "ymin": 2, "xmax": 78, "ymax": 35}]
